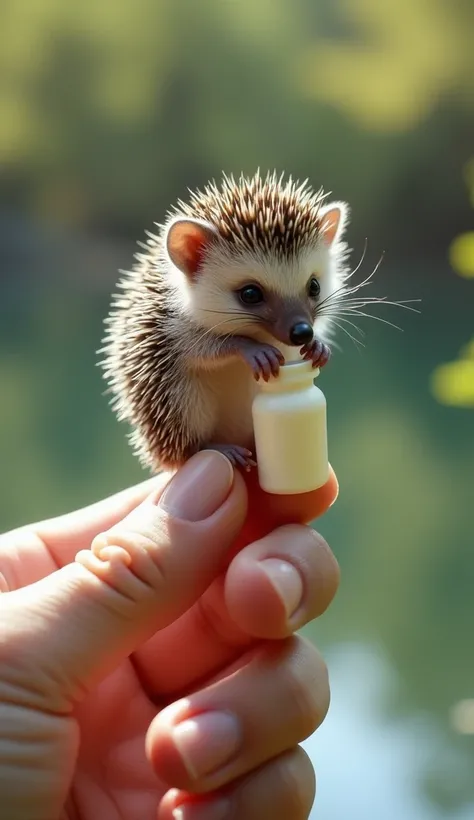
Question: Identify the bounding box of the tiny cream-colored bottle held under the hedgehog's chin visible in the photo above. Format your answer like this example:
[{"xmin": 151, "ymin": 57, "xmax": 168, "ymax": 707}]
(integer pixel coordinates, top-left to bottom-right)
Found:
[{"xmin": 252, "ymin": 361, "xmax": 329, "ymax": 495}]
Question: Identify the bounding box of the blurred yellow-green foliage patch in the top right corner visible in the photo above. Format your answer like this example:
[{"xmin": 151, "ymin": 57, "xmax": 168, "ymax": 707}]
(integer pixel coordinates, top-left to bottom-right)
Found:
[{"xmin": 301, "ymin": 0, "xmax": 474, "ymax": 132}]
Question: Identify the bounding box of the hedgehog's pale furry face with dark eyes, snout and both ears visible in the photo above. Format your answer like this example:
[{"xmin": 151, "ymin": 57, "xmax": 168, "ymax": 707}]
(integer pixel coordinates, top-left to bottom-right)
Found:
[{"xmin": 166, "ymin": 175, "xmax": 347, "ymax": 346}]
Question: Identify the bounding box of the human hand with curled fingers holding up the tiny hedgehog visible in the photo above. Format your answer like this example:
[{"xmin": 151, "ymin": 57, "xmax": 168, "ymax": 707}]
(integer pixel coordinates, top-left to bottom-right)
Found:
[{"xmin": 0, "ymin": 452, "xmax": 339, "ymax": 820}]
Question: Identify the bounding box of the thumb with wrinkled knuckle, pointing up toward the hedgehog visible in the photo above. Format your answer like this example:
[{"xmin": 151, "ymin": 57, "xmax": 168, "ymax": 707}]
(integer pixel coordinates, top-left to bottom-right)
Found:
[{"xmin": 0, "ymin": 451, "xmax": 247, "ymax": 711}]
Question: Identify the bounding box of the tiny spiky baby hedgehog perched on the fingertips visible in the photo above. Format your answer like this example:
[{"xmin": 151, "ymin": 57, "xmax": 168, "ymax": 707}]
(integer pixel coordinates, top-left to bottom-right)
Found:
[{"xmin": 101, "ymin": 172, "xmax": 348, "ymax": 472}]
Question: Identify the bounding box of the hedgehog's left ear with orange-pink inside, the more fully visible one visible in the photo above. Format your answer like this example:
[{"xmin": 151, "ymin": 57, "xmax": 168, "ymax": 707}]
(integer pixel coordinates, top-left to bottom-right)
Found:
[{"xmin": 166, "ymin": 217, "xmax": 218, "ymax": 279}]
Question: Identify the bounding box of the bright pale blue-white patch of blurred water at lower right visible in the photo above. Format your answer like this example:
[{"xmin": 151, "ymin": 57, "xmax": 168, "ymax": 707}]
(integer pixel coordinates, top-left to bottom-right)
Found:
[{"xmin": 302, "ymin": 644, "xmax": 474, "ymax": 820}]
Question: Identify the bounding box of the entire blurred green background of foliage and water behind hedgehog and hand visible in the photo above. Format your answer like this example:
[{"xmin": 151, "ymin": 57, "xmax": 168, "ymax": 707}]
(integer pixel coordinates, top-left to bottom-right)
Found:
[{"xmin": 0, "ymin": 0, "xmax": 474, "ymax": 820}]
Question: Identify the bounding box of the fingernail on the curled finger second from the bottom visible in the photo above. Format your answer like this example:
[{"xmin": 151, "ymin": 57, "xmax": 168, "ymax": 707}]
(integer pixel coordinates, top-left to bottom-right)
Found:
[{"xmin": 173, "ymin": 712, "xmax": 241, "ymax": 780}]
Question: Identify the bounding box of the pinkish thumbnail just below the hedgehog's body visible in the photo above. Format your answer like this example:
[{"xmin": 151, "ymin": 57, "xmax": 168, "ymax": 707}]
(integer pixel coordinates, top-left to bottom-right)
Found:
[{"xmin": 160, "ymin": 450, "xmax": 234, "ymax": 521}]
